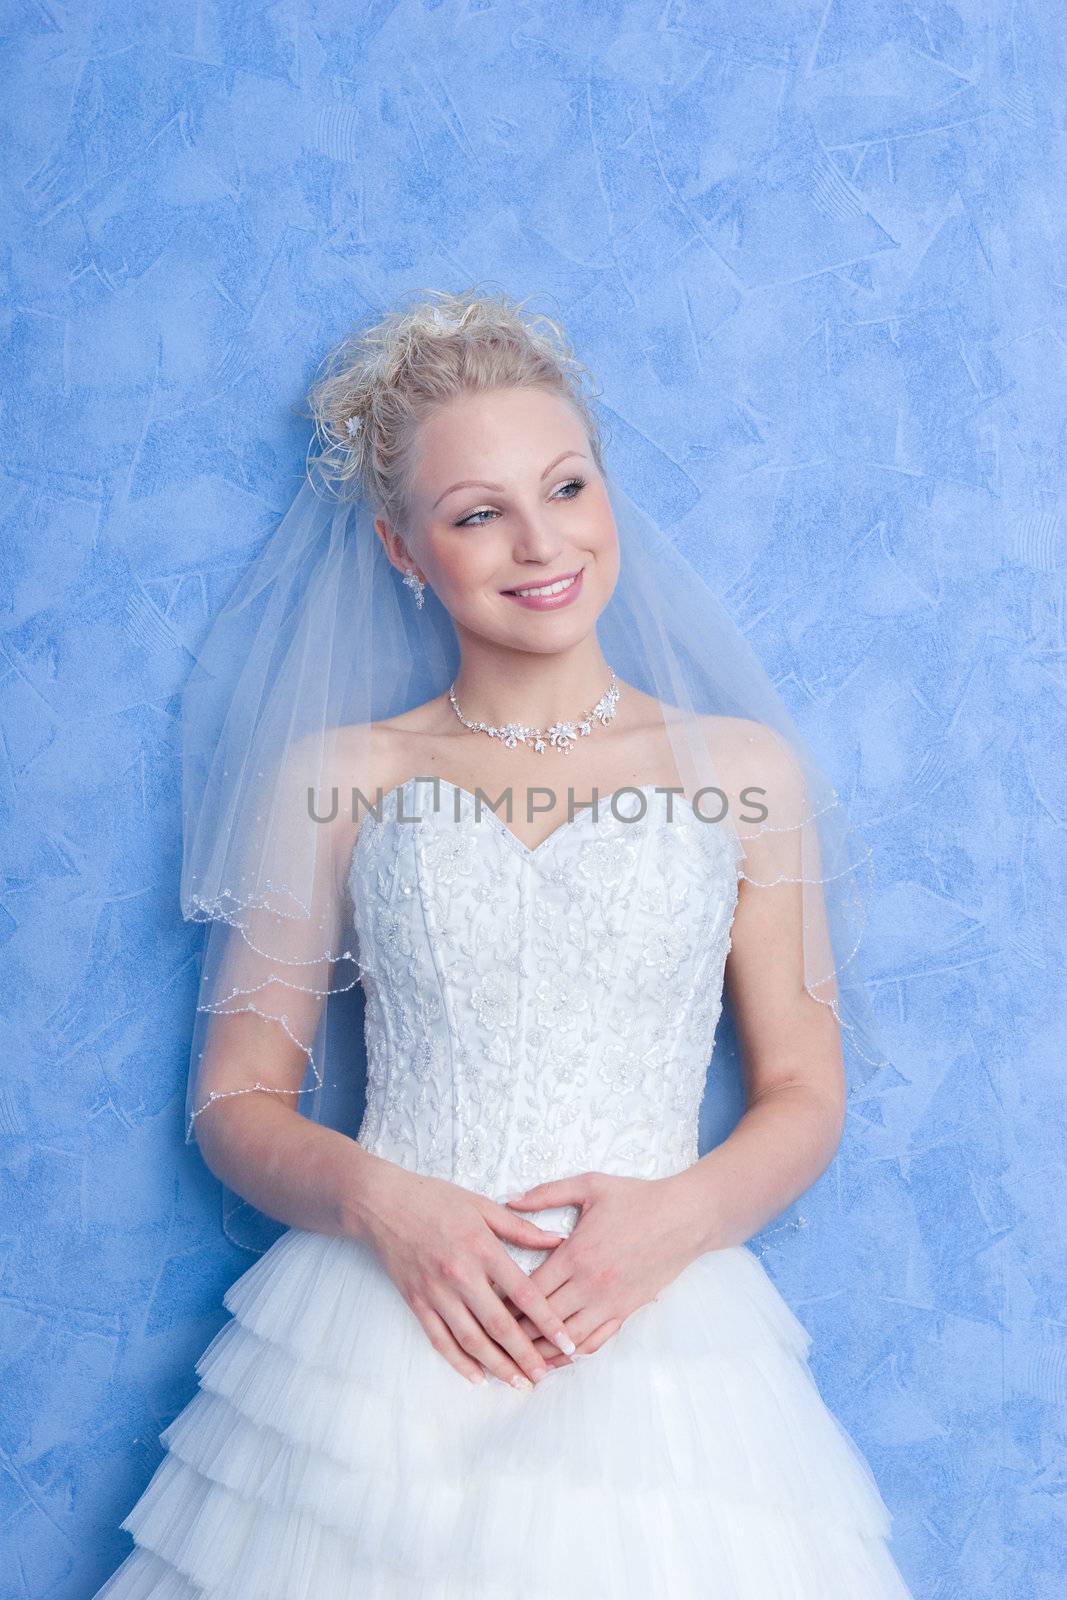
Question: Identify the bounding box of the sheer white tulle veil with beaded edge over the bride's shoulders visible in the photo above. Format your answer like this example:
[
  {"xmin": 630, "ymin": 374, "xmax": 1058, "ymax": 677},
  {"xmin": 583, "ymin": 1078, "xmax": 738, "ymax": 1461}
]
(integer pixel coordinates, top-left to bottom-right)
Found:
[{"xmin": 181, "ymin": 438, "xmax": 885, "ymax": 1251}]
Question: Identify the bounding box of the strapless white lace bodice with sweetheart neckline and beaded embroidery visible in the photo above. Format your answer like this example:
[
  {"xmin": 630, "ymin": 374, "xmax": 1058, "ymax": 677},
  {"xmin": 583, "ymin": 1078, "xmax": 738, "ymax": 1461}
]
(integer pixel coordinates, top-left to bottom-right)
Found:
[{"xmin": 349, "ymin": 778, "xmax": 737, "ymax": 1270}]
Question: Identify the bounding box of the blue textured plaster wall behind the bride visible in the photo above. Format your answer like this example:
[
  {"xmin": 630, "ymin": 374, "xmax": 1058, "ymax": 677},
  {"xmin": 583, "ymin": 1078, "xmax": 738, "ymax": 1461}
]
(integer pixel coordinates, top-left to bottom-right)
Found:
[{"xmin": 0, "ymin": 0, "xmax": 1067, "ymax": 1600}]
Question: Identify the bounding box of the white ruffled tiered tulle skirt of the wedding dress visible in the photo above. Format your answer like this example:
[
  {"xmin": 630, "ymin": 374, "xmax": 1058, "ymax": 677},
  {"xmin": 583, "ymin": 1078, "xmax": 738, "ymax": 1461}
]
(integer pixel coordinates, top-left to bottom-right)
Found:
[{"xmin": 94, "ymin": 1224, "xmax": 909, "ymax": 1600}]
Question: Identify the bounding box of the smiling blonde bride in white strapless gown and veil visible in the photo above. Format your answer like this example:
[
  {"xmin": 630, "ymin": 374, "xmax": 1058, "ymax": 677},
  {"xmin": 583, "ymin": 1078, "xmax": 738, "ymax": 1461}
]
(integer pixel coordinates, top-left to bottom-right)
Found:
[{"xmin": 98, "ymin": 293, "xmax": 907, "ymax": 1600}]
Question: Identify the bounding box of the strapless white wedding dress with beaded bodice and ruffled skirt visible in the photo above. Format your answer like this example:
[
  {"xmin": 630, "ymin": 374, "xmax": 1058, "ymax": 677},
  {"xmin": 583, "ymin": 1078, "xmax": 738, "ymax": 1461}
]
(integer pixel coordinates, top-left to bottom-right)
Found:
[{"xmin": 96, "ymin": 779, "xmax": 909, "ymax": 1600}]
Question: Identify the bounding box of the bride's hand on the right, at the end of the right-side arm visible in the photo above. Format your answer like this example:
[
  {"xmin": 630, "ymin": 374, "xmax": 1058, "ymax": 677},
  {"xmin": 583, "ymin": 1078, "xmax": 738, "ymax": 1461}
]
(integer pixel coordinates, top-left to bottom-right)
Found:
[{"xmin": 506, "ymin": 1173, "xmax": 702, "ymax": 1366}]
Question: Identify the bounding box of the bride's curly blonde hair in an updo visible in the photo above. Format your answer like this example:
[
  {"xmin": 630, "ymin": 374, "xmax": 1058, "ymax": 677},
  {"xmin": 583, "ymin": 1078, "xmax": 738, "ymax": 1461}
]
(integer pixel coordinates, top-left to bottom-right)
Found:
[{"xmin": 307, "ymin": 288, "xmax": 603, "ymax": 528}]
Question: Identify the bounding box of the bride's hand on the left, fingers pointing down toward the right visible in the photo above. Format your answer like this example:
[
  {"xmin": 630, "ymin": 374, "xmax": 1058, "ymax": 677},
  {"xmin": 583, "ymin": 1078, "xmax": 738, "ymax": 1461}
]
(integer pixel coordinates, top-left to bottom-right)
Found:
[{"xmin": 362, "ymin": 1162, "xmax": 574, "ymax": 1389}]
